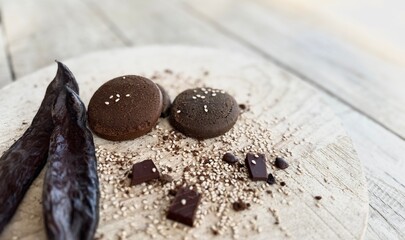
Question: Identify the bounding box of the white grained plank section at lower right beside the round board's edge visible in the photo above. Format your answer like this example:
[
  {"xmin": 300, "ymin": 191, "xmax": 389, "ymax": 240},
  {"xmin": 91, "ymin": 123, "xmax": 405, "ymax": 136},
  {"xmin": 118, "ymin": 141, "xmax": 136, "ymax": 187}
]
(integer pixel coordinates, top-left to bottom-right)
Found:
[{"xmin": 327, "ymin": 96, "xmax": 405, "ymax": 239}]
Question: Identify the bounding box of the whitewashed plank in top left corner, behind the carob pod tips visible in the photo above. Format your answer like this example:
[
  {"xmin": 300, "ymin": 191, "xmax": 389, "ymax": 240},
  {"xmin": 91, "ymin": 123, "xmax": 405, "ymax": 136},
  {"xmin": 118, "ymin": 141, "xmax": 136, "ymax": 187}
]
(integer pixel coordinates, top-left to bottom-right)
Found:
[{"xmin": 2, "ymin": 0, "xmax": 123, "ymax": 78}]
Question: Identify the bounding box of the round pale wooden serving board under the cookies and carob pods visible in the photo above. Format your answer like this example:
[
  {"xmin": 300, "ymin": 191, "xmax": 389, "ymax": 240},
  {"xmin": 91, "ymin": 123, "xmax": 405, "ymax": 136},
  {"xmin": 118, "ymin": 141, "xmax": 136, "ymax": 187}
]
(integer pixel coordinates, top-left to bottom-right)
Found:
[{"xmin": 0, "ymin": 46, "xmax": 368, "ymax": 239}]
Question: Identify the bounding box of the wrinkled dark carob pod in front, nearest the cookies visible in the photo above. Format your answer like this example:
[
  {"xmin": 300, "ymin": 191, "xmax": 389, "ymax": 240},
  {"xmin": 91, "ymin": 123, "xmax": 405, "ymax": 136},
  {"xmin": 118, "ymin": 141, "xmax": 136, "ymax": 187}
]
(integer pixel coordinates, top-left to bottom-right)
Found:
[{"xmin": 42, "ymin": 87, "xmax": 99, "ymax": 240}]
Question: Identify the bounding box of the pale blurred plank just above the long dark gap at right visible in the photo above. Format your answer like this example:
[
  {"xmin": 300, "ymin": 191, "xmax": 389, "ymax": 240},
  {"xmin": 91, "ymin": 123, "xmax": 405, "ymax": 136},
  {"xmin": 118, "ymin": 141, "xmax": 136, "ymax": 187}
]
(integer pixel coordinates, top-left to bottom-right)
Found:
[{"xmin": 184, "ymin": 0, "xmax": 405, "ymax": 138}]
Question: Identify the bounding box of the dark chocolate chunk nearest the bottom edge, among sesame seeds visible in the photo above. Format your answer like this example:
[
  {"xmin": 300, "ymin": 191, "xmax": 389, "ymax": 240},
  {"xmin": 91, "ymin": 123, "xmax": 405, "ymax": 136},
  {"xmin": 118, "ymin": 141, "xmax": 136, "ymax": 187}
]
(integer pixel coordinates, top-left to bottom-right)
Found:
[{"xmin": 167, "ymin": 187, "xmax": 201, "ymax": 227}]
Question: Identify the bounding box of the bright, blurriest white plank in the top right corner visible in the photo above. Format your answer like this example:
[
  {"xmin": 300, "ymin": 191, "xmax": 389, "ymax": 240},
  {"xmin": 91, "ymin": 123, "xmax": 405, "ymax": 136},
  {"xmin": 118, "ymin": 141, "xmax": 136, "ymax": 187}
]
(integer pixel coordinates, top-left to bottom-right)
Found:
[{"xmin": 259, "ymin": 0, "xmax": 405, "ymax": 66}]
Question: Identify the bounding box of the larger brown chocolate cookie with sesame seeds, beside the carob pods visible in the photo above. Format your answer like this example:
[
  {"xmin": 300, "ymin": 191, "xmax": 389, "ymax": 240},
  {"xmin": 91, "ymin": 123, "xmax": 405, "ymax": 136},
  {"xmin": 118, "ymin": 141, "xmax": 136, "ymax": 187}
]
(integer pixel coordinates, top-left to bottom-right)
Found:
[{"xmin": 88, "ymin": 75, "xmax": 162, "ymax": 141}]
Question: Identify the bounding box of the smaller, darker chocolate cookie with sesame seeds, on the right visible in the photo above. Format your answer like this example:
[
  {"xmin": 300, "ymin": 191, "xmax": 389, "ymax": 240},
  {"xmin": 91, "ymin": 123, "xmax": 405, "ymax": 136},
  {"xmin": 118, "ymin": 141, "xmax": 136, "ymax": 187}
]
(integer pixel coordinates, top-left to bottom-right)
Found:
[{"xmin": 170, "ymin": 88, "xmax": 239, "ymax": 139}]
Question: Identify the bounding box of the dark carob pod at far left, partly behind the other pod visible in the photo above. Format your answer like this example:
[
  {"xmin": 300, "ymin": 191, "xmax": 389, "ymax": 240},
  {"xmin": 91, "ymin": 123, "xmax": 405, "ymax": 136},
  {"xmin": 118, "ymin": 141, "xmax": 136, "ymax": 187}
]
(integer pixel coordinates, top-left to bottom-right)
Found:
[{"xmin": 0, "ymin": 62, "xmax": 79, "ymax": 233}]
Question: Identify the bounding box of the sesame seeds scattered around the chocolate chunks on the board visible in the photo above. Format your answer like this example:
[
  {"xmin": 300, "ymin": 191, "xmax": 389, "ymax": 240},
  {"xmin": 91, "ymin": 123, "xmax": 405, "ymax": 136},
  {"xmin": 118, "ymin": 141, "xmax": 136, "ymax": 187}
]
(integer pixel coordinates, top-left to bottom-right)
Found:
[{"xmin": 96, "ymin": 70, "xmax": 310, "ymax": 239}]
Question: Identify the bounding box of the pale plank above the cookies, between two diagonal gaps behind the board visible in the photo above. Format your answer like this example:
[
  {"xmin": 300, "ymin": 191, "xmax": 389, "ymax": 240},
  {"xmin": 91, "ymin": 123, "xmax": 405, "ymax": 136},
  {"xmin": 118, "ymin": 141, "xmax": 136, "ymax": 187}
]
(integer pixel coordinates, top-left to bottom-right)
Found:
[{"xmin": 83, "ymin": 0, "xmax": 251, "ymax": 54}]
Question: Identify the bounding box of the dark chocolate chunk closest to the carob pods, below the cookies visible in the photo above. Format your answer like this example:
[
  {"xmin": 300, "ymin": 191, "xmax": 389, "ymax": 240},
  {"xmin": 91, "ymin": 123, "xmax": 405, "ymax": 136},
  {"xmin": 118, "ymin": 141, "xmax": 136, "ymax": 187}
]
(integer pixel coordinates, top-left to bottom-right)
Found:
[{"xmin": 131, "ymin": 159, "xmax": 159, "ymax": 186}]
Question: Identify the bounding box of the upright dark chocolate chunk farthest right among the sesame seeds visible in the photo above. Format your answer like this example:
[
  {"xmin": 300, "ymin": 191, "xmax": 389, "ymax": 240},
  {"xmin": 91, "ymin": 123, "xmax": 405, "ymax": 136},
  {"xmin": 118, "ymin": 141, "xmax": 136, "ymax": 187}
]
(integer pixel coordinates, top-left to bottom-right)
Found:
[{"xmin": 245, "ymin": 153, "xmax": 267, "ymax": 181}]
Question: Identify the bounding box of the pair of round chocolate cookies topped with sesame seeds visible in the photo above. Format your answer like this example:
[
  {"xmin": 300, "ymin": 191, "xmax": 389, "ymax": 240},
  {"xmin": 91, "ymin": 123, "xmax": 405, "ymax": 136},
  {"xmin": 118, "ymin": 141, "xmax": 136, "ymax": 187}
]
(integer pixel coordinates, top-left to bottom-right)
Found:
[{"xmin": 88, "ymin": 75, "xmax": 239, "ymax": 141}]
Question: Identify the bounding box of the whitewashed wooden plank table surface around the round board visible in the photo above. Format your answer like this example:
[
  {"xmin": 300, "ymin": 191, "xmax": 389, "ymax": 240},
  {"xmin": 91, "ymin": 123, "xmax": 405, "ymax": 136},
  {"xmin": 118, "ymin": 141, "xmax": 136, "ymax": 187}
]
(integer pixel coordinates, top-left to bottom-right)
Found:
[{"xmin": 0, "ymin": 0, "xmax": 405, "ymax": 239}]
